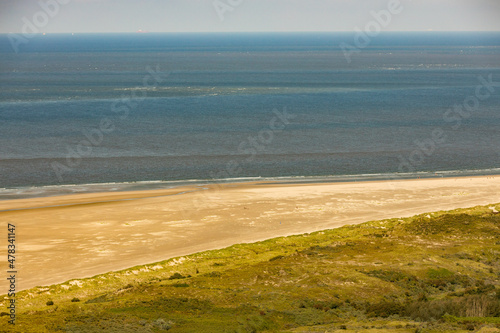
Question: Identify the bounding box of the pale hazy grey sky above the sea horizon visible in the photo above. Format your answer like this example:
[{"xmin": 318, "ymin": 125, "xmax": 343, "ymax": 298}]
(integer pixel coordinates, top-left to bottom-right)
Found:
[{"xmin": 0, "ymin": 0, "xmax": 500, "ymax": 33}]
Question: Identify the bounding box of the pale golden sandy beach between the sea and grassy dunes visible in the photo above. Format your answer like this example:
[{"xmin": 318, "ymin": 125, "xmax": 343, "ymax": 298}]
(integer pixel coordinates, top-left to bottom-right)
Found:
[{"xmin": 0, "ymin": 176, "xmax": 500, "ymax": 293}]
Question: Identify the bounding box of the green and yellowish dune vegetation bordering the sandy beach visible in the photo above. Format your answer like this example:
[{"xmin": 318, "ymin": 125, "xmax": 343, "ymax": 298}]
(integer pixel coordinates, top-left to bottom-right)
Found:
[{"xmin": 0, "ymin": 204, "xmax": 500, "ymax": 333}]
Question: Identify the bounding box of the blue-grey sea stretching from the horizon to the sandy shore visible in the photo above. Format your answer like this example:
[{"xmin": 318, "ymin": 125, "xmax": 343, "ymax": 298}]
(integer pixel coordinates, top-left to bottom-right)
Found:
[{"xmin": 0, "ymin": 33, "xmax": 500, "ymax": 188}]
